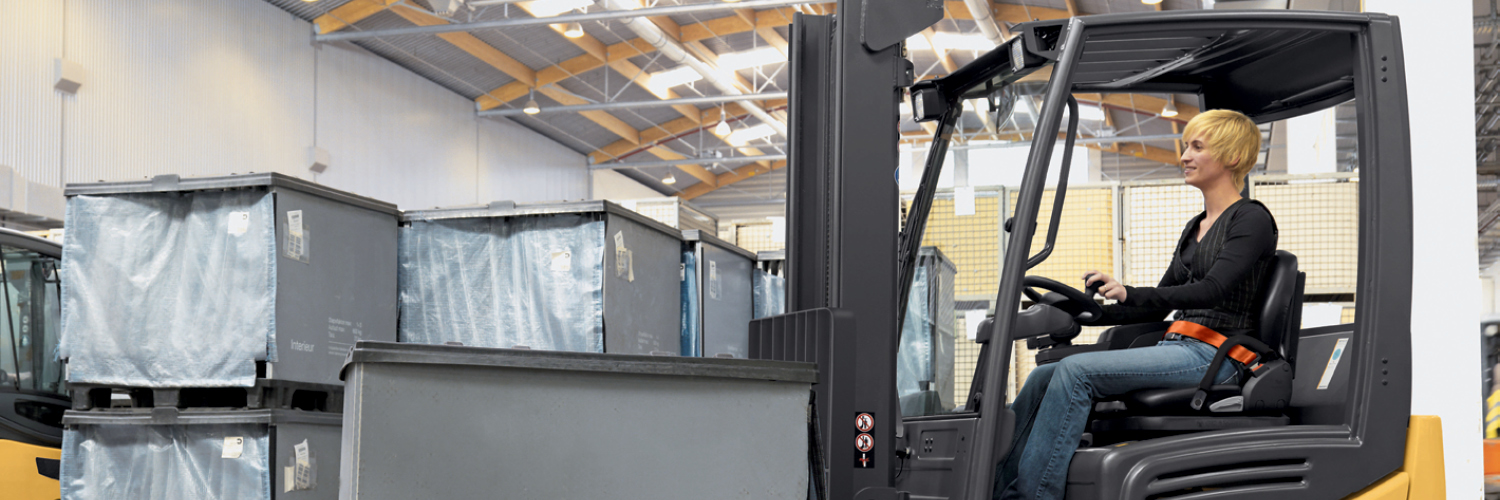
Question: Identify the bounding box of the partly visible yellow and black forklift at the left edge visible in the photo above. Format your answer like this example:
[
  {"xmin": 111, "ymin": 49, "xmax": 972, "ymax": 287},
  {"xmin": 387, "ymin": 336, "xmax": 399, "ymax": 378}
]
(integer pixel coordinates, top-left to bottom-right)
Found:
[{"xmin": 0, "ymin": 228, "xmax": 72, "ymax": 500}]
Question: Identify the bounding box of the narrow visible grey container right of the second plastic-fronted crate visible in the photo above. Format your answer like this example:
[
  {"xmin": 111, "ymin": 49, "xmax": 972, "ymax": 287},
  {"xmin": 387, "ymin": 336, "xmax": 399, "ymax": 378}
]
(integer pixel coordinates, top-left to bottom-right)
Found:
[{"xmin": 683, "ymin": 230, "xmax": 755, "ymax": 359}]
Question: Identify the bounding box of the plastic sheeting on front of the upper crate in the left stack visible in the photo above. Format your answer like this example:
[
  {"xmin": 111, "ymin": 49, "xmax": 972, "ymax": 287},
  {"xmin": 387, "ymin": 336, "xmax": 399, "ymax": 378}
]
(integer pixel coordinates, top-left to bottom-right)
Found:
[{"xmin": 60, "ymin": 189, "xmax": 276, "ymax": 387}]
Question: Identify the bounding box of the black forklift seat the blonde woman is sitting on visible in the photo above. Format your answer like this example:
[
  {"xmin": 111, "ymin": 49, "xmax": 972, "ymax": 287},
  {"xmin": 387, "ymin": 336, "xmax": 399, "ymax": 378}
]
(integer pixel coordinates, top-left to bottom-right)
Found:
[{"xmin": 1091, "ymin": 251, "xmax": 1305, "ymax": 435}]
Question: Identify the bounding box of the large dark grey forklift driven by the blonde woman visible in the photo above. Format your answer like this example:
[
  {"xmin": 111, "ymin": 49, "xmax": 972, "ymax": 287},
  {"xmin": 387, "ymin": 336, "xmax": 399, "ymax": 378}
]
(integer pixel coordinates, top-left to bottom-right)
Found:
[{"xmin": 750, "ymin": 0, "xmax": 1445, "ymax": 500}]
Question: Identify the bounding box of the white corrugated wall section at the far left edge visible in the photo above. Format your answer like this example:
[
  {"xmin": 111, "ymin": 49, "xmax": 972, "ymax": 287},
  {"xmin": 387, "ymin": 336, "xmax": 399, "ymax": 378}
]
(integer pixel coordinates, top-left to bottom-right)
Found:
[{"xmin": 0, "ymin": 2, "xmax": 63, "ymax": 186}]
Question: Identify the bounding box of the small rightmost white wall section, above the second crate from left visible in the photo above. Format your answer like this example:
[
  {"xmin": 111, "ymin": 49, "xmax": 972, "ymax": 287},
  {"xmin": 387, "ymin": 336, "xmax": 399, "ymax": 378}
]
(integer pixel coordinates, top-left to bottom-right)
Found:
[{"xmin": 479, "ymin": 119, "xmax": 590, "ymax": 203}]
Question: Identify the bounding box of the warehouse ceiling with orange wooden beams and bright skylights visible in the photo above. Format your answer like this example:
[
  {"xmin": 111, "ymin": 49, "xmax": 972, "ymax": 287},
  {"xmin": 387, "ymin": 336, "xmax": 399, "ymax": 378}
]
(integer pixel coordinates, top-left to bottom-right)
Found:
[{"xmin": 267, "ymin": 0, "xmax": 1368, "ymax": 221}]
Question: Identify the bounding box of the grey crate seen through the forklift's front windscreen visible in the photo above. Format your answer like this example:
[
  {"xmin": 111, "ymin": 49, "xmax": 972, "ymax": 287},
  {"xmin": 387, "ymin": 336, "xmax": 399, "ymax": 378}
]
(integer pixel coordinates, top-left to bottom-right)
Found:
[{"xmin": 896, "ymin": 246, "xmax": 959, "ymax": 416}]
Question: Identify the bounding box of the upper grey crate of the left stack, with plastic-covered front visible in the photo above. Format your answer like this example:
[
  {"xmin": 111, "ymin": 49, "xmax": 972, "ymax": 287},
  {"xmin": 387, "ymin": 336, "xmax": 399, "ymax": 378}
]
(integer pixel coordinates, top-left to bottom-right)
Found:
[{"xmin": 60, "ymin": 173, "xmax": 398, "ymax": 387}]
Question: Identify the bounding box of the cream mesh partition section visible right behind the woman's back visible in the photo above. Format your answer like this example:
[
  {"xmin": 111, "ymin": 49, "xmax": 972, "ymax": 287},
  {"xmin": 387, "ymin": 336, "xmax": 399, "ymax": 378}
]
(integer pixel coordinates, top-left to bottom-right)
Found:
[{"xmin": 1250, "ymin": 174, "xmax": 1359, "ymax": 296}]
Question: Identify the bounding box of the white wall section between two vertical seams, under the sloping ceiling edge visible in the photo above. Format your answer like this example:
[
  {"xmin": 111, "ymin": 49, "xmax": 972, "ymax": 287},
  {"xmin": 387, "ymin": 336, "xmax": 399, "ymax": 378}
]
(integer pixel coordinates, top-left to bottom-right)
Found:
[{"xmin": 317, "ymin": 39, "xmax": 480, "ymax": 209}]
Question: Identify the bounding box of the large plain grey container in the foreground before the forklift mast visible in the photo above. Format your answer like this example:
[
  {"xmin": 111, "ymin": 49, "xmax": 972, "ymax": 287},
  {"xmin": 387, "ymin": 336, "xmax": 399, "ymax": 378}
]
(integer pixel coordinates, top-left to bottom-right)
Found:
[{"xmin": 339, "ymin": 342, "xmax": 816, "ymax": 500}]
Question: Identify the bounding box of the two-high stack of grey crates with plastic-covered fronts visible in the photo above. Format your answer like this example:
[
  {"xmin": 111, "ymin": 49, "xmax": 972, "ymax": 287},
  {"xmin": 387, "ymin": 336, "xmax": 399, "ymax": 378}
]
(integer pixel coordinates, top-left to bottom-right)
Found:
[{"xmin": 60, "ymin": 174, "xmax": 398, "ymax": 498}]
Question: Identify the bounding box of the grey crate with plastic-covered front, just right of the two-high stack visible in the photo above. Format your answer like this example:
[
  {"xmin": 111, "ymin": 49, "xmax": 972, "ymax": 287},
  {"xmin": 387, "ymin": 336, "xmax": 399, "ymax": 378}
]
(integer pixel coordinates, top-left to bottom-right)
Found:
[{"xmin": 401, "ymin": 201, "xmax": 683, "ymax": 356}]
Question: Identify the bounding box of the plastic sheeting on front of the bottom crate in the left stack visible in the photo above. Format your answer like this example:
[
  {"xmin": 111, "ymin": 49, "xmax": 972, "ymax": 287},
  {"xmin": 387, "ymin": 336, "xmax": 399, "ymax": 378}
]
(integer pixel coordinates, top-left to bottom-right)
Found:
[{"xmin": 60, "ymin": 423, "xmax": 272, "ymax": 500}]
